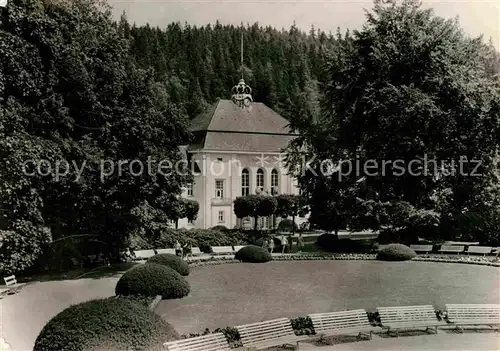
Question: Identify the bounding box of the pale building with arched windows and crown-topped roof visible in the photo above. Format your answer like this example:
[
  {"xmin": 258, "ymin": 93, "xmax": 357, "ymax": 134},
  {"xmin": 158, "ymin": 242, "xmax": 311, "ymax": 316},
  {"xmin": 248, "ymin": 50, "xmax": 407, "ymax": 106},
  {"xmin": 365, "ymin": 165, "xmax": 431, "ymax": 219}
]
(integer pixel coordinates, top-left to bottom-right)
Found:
[{"xmin": 179, "ymin": 81, "xmax": 303, "ymax": 229}]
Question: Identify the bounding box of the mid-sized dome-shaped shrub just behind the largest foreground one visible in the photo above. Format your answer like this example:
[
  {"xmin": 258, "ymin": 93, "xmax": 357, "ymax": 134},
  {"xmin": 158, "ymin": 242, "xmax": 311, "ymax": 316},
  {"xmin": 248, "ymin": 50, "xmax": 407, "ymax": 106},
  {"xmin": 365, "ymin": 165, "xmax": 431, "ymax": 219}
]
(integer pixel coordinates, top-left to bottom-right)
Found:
[{"xmin": 115, "ymin": 263, "xmax": 191, "ymax": 300}]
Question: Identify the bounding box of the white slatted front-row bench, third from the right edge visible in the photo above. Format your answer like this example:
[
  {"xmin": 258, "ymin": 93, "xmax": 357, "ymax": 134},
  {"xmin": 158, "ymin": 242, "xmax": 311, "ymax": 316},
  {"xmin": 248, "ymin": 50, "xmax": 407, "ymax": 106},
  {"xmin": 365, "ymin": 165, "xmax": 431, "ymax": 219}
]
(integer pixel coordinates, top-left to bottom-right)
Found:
[{"xmin": 309, "ymin": 309, "xmax": 380, "ymax": 339}]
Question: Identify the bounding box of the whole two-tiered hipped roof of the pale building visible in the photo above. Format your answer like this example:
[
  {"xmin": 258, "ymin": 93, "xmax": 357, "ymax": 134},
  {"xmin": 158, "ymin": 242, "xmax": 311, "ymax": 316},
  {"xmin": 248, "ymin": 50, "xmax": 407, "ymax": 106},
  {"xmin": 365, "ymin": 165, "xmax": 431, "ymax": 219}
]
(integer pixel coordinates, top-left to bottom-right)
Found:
[{"xmin": 188, "ymin": 100, "xmax": 297, "ymax": 152}]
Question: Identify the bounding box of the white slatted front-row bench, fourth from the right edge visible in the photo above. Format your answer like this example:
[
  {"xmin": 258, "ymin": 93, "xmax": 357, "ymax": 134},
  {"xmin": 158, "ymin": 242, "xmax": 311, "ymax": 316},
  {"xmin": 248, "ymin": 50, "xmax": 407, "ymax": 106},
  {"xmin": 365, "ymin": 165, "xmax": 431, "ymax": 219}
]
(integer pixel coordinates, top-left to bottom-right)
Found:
[{"xmin": 236, "ymin": 318, "xmax": 307, "ymax": 350}]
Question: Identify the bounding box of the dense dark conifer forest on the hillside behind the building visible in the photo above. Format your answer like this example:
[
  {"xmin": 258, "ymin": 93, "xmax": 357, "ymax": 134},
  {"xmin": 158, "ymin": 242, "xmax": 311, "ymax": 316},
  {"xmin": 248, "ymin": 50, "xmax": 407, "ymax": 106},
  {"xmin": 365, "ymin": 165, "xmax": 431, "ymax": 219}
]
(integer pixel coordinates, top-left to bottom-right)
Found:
[{"xmin": 119, "ymin": 14, "xmax": 500, "ymax": 118}]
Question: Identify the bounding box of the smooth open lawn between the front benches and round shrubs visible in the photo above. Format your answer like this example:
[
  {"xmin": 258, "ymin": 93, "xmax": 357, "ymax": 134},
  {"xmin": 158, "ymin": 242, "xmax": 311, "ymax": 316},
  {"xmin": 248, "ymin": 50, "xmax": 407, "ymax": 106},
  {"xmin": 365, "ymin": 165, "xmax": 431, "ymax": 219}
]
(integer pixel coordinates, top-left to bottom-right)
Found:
[{"xmin": 156, "ymin": 261, "xmax": 500, "ymax": 334}]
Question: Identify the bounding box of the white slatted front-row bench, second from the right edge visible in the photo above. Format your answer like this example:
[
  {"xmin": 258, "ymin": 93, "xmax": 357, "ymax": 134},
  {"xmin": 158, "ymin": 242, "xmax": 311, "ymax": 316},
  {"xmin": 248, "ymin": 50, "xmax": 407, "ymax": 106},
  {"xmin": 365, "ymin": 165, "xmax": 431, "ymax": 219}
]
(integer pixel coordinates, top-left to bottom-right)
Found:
[{"xmin": 377, "ymin": 305, "xmax": 443, "ymax": 334}]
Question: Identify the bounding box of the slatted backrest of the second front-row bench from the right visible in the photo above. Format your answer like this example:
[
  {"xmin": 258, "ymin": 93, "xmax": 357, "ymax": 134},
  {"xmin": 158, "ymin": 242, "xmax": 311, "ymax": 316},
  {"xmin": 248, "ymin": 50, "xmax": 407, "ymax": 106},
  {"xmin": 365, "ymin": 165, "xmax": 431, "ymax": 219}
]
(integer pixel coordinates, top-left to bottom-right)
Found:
[{"xmin": 377, "ymin": 305, "xmax": 437, "ymax": 325}]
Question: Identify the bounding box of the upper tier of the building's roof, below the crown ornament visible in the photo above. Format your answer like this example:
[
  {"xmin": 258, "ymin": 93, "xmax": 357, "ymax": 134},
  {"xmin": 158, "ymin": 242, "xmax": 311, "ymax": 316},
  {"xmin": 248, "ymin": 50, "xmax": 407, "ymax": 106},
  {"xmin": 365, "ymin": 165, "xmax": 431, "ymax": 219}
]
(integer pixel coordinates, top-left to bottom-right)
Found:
[{"xmin": 189, "ymin": 100, "xmax": 296, "ymax": 135}]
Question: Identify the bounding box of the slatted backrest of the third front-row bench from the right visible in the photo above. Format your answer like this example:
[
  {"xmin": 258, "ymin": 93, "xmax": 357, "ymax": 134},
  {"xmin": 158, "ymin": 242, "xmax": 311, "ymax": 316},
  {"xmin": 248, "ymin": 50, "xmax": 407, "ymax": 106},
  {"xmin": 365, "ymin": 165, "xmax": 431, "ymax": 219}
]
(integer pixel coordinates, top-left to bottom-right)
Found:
[{"xmin": 309, "ymin": 309, "xmax": 371, "ymax": 333}]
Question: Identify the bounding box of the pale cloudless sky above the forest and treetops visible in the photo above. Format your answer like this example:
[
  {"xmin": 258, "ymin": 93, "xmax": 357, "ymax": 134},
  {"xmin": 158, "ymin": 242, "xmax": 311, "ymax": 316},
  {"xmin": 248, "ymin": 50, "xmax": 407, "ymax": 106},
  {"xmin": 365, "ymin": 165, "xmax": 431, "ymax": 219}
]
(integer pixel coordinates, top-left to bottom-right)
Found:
[{"xmin": 108, "ymin": 0, "xmax": 500, "ymax": 49}]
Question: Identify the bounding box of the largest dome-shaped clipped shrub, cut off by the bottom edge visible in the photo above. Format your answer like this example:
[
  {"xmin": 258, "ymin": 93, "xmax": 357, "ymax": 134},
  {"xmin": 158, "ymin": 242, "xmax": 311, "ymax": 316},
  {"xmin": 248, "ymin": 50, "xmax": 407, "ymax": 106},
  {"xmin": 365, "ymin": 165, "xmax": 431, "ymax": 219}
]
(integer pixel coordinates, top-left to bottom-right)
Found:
[{"xmin": 33, "ymin": 297, "xmax": 180, "ymax": 351}]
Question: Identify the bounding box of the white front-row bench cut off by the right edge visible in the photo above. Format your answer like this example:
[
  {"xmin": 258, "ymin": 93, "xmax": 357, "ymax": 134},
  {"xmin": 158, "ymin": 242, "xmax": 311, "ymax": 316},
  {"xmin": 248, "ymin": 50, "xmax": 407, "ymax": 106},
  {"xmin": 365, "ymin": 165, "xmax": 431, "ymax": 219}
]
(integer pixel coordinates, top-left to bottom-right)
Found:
[{"xmin": 446, "ymin": 304, "xmax": 500, "ymax": 330}]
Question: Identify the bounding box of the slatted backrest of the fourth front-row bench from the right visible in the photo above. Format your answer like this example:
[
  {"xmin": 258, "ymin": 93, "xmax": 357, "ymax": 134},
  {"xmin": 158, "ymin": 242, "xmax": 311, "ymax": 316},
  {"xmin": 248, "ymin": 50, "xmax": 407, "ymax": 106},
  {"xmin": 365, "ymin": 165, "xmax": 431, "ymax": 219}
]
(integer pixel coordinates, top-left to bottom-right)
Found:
[{"xmin": 236, "ymin": 318, "xmax": 295, "ymax": 346}]
